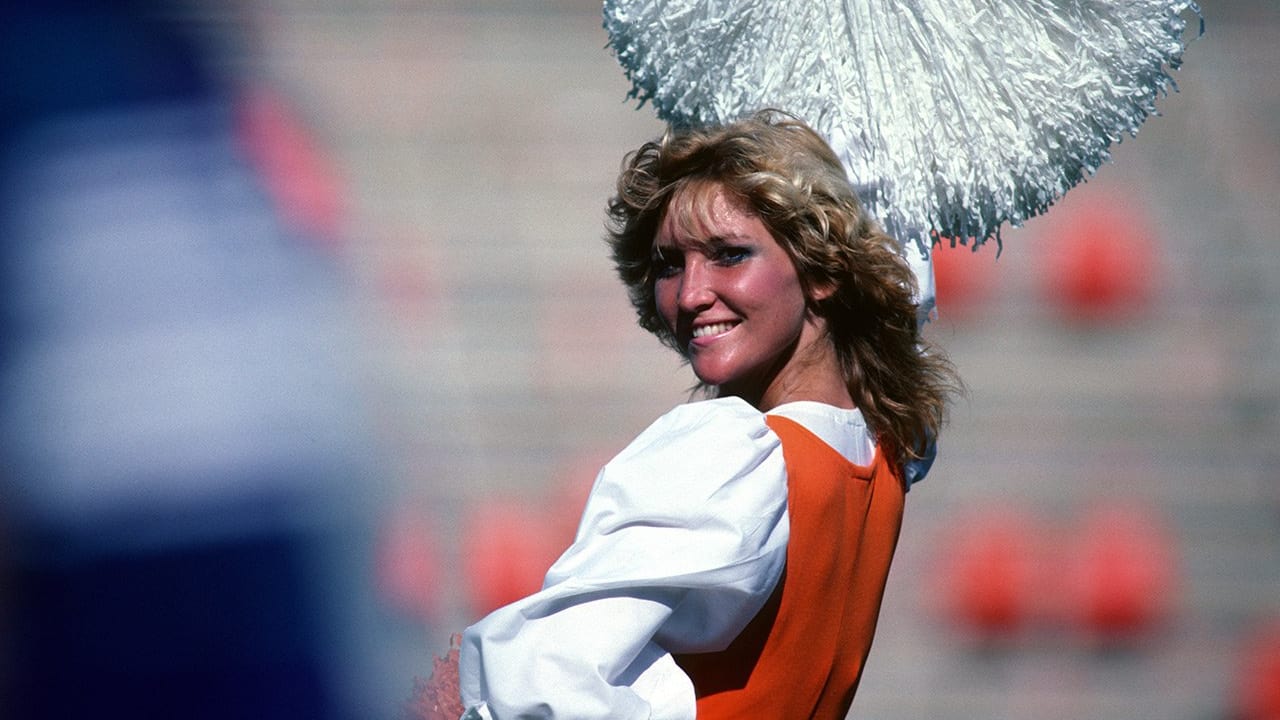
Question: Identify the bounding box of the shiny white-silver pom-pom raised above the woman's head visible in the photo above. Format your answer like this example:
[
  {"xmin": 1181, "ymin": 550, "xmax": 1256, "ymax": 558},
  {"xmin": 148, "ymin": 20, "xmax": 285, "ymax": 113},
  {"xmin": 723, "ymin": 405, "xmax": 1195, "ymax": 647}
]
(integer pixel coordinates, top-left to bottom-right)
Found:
[{"xmin": 604, "ymin": 0, "xmax": 1203, "ymax": 256}]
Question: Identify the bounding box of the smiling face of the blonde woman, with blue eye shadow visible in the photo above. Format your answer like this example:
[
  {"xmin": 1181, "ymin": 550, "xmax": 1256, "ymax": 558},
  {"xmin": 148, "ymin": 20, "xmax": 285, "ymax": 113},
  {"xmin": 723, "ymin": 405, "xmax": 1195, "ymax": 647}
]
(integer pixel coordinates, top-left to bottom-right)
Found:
[{"xmin": 654, "ymin": 187, "xmax": 823, "ymax": 409}]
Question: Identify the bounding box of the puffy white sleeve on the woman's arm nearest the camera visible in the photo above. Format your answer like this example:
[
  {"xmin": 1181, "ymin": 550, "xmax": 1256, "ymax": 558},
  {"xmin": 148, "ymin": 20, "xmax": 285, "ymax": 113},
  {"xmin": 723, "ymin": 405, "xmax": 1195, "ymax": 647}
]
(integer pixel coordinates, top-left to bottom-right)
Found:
[{"xmin": 460, "ymin": 398, "xmax": 790, "ymax": 720}]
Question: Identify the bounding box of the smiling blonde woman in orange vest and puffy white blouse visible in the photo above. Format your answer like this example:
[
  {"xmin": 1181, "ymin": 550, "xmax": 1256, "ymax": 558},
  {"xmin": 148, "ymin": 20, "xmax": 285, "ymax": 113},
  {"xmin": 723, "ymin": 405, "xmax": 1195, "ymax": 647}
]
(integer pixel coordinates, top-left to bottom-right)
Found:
[{"xmin": 460, "ymin": 111, "xmax": 959, "ymax": 720}]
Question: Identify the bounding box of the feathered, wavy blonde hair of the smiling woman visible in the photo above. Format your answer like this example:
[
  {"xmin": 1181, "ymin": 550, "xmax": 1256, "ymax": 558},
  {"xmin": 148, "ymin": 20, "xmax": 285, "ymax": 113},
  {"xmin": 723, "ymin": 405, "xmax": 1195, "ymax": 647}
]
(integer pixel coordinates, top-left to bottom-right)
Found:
[{"xmin": 608, "ymin": 110, "xmax": 960, "ymax": 457}]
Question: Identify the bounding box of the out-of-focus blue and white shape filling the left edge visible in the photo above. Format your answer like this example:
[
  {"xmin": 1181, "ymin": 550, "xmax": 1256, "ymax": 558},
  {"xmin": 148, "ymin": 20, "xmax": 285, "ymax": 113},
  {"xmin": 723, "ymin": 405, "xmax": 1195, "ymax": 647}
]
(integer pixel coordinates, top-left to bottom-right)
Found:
[{"xmin": 0, "ymin": 3, "xmax": 369, "ymax": 719}]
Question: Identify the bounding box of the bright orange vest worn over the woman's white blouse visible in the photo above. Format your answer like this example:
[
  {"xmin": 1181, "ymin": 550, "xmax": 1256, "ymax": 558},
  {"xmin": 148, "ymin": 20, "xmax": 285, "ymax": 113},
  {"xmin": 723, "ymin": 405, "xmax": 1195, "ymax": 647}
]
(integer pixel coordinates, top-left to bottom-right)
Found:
[{"xmin": 676, "ymin": 415, "xmax": 904, "ymax": 720}]
